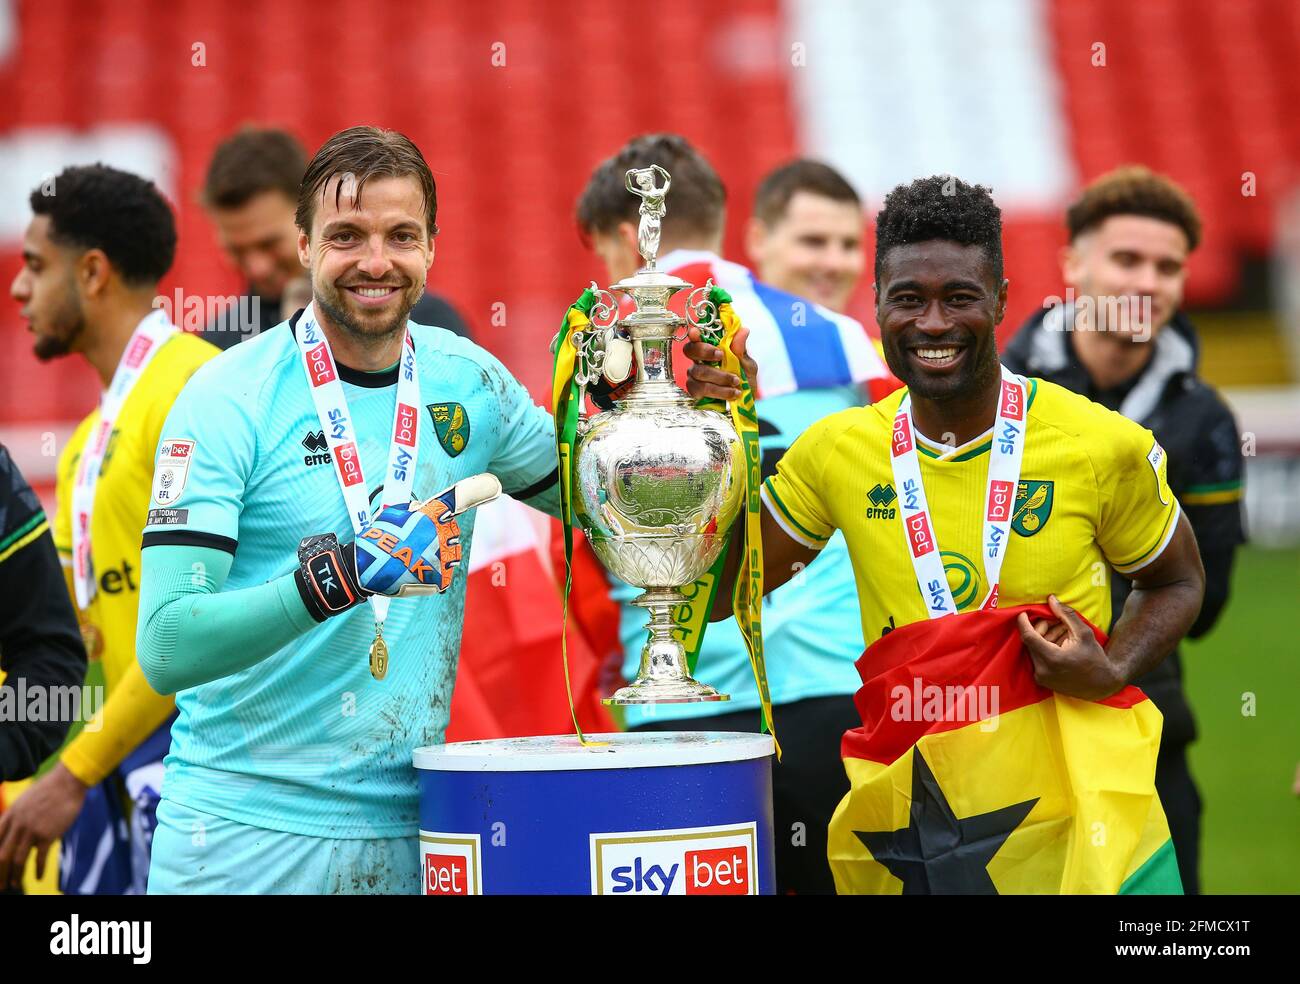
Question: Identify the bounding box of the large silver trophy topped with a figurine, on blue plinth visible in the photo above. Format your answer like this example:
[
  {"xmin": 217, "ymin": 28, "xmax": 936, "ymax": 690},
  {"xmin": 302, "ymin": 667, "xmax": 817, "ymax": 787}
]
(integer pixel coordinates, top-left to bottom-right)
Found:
[{"xmin": 573, "ymin": 165, "xmax": 745, "ymax": 705}]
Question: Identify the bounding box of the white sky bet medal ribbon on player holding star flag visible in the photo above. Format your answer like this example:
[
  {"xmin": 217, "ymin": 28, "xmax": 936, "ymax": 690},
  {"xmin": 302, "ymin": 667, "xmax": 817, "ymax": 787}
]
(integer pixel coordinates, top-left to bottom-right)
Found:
[{"xmin": 889, "ymin": 367, "xmax": 1027, "ymax": 619}]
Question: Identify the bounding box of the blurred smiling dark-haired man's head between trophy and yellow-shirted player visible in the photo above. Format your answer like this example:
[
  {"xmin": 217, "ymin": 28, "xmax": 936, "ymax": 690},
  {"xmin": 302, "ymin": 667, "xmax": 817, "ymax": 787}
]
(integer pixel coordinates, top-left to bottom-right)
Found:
[{"xmin": 745, "ymin": 160, "xmax": 867, "ymax": 312}]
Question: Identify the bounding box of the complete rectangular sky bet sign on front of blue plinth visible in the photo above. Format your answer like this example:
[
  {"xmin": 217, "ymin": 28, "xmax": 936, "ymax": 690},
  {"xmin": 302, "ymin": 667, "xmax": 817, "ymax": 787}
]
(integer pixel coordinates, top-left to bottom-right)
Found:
[{"xmin": 592, "ymin": 823, "xmax": 758, "ymax": 896}]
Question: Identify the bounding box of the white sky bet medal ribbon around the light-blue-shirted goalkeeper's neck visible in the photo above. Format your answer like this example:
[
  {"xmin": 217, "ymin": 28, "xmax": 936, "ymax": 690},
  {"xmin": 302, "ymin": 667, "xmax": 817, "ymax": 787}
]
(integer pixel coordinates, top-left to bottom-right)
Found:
[{"xmin": 295, "ymin": 303, "xmax": 420, "ymax": 634}]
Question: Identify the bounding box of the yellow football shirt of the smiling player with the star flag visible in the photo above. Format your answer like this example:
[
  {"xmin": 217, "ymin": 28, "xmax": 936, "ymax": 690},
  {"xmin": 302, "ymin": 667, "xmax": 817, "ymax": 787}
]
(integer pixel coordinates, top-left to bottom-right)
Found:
[{"xmin": 763, "ymin": 380, "xmax": 1179, "ymax": 645}]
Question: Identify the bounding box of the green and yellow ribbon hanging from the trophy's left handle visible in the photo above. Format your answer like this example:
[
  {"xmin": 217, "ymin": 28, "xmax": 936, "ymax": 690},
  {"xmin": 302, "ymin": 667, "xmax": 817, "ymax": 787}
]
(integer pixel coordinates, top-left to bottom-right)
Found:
[{"xmin": 551, "ymin": 287, "xmax": 608, "ymax": 745}]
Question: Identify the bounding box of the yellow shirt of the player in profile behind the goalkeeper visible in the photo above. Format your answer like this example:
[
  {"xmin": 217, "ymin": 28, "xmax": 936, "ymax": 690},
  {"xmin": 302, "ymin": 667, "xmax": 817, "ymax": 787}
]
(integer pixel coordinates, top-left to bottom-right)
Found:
[{"xmin": 53, "ymin": 331, "xmax": 220, "ymax": 785}]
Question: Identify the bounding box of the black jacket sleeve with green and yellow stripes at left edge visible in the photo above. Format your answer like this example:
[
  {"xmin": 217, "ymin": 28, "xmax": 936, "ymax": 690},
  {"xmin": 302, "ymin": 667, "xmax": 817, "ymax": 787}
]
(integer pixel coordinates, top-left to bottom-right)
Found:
[{"xmin": 0, "ymin": 445, "xmax": 86, "ymax": 785}]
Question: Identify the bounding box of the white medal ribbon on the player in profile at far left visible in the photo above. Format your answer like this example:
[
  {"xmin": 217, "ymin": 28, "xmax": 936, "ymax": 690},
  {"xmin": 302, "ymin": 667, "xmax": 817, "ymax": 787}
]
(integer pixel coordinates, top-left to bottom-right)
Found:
[{"xmin": 73, "ymin": 311, "xmax": 179, "ymax": 608}]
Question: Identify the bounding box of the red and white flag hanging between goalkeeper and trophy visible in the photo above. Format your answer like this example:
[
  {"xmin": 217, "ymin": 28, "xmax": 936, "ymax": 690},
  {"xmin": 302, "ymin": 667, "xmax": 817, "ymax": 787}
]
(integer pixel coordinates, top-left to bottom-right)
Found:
[{"xmin": 447, "ymin": 497, "xmax": 619, "ymax": 741}]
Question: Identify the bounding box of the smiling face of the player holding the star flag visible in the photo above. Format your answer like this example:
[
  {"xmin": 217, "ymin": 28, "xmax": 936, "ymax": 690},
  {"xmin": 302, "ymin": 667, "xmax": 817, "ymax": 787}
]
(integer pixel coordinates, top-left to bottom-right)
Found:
[{"xmin": 876, "ymin": 239, "xmax": 1006, "ymax": 400}]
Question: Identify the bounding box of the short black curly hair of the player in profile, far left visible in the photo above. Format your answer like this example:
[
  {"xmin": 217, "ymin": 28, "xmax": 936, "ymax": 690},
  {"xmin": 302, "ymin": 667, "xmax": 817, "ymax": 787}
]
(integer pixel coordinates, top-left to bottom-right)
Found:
[{"xmin": 30, "ymin": 164, "xmax": 176, "ymax": 287}]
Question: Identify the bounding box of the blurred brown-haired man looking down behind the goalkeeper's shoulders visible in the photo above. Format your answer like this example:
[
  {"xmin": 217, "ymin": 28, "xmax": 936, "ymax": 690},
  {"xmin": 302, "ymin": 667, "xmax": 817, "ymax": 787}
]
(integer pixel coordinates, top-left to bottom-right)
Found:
[{"xmin": 202, "ymin": 127, "xmax": 468, "ymax": 348}]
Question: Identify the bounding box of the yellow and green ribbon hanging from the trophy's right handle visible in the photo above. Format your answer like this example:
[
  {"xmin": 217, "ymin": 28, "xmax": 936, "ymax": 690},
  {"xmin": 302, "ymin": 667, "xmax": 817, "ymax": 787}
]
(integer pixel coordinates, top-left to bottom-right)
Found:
[{"xmin": 673, "ymin": 283, "xmax": 781, "ymax": 760}]
